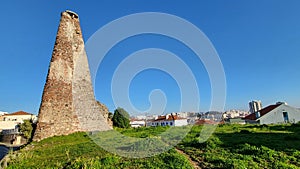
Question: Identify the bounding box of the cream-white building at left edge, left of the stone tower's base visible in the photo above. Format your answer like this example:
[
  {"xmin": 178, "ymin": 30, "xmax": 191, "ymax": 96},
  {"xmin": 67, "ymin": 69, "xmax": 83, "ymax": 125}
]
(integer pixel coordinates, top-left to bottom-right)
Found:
[{"xmin": 0, "ymin": 111, "xmax": 37, "ymax": 134}]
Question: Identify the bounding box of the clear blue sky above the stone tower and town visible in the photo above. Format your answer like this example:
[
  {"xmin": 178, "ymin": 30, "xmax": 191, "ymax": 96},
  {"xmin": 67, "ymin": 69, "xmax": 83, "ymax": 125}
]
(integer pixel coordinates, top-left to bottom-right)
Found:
[{"xmin": 0, "ymin": 0, "xmax": 300, "ymax": 114}]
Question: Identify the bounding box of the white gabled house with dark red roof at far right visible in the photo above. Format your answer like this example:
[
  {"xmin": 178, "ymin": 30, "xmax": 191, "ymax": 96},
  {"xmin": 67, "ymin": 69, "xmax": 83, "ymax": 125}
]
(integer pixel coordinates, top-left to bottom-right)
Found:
[{"xmin": 245, "ymin": 102, "xmax": 300, "ymax": 124}]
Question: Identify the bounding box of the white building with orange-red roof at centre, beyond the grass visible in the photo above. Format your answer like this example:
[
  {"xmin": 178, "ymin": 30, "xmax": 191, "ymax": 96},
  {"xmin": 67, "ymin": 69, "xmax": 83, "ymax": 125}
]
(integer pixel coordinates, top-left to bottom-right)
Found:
[{"xmin": 147, "ymin": 114, "xmax": 188, "ymax": 126}]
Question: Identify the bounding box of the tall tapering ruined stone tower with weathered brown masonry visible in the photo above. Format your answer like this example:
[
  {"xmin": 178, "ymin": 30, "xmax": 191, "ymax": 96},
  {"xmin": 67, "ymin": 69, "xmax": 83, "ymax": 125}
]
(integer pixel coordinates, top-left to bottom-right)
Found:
[{"xmin": 33, "ymin": 11, "xmax": 112, "ymax": 141}]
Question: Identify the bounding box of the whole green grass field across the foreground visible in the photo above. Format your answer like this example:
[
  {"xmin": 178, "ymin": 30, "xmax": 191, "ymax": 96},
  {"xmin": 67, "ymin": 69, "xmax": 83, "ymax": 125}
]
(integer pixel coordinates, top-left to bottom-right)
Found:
[{"xmin": 2, "ymin": 124, "xmax": 300, "ymax": 169}]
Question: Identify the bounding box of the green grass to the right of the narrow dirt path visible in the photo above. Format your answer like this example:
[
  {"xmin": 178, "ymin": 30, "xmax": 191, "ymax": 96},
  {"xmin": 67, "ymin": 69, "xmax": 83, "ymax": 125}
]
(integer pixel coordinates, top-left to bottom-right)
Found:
[{"xmin": 177, "ymin": 124, "xmax": 300, "ymax": 168}]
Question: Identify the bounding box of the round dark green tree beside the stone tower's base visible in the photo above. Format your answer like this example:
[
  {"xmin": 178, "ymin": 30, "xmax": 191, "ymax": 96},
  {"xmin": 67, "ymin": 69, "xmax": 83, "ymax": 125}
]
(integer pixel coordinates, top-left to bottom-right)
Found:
[{"xmin": 112, "ymin": 107, "xmax": 130, "ymax": 128}]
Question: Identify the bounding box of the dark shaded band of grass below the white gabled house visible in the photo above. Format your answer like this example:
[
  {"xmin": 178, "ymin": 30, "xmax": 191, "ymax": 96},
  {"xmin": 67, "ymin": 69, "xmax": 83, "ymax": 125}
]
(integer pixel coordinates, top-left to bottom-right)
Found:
[{"xmin": 180, "ymin": 124, "xmax": 300, "ymax": 151}]
